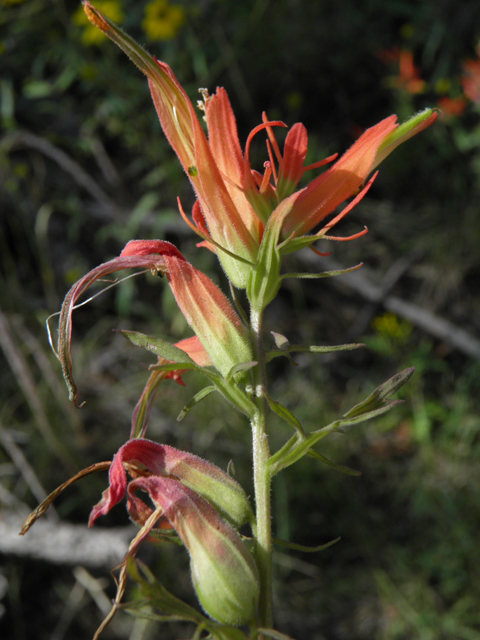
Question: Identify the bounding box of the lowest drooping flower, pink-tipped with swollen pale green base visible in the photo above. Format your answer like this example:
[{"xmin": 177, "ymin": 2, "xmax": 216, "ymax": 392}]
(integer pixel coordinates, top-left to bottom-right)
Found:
[{"xmin": 128, "ymin": 476, "xmax": 259, "ymax": 626}]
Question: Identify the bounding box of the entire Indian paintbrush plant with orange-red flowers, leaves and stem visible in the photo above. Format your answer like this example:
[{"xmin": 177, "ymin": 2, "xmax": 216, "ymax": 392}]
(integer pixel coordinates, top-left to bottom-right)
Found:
[{"xmin": 33, "ymin": 2, "xmax": 438, "ymax": 638}]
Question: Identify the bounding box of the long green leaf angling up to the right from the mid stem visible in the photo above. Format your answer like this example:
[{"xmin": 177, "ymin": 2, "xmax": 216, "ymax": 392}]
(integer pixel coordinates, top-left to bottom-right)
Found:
[{"xmin": 268, "ymin": 367, "xmax": 414, "ymax": 476}]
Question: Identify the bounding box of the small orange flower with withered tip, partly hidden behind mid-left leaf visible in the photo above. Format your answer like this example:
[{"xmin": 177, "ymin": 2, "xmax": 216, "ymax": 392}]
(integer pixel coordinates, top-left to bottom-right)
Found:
[{"xmin": 130, "ymin": 336, "xmax": 213, "ymax": 438}]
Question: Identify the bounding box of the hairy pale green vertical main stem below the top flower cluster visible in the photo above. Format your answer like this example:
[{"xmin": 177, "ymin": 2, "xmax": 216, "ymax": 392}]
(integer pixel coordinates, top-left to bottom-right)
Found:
[{"xmin": 250, "ymin": 309, "xmax": 273, "ymax": 628}]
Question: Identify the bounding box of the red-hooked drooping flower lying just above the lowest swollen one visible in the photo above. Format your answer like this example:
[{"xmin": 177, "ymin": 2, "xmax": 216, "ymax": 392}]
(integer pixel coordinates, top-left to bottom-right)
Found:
[{"xmin": 89, "ymin": 438, "xmax": 253, "ymax": 528}]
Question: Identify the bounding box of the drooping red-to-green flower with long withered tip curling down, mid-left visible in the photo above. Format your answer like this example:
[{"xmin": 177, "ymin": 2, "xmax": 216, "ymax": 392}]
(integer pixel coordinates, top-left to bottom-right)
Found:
[{"xmin": 58, "ymin": 240, "xmax": 253, "ymax": 404}]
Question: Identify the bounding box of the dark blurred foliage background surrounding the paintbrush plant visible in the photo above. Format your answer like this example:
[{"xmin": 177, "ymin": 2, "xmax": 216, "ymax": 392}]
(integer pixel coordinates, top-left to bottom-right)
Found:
[{"xmin": 0, "ymin": 0, "xmax": 480, "ymax": 640}]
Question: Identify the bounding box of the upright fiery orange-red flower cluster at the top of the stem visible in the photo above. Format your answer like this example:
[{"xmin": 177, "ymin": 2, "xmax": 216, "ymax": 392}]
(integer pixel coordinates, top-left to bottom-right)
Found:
[{"xmin": 84, "ymin": 2, "xmax": 438, "ymax": 299}]
